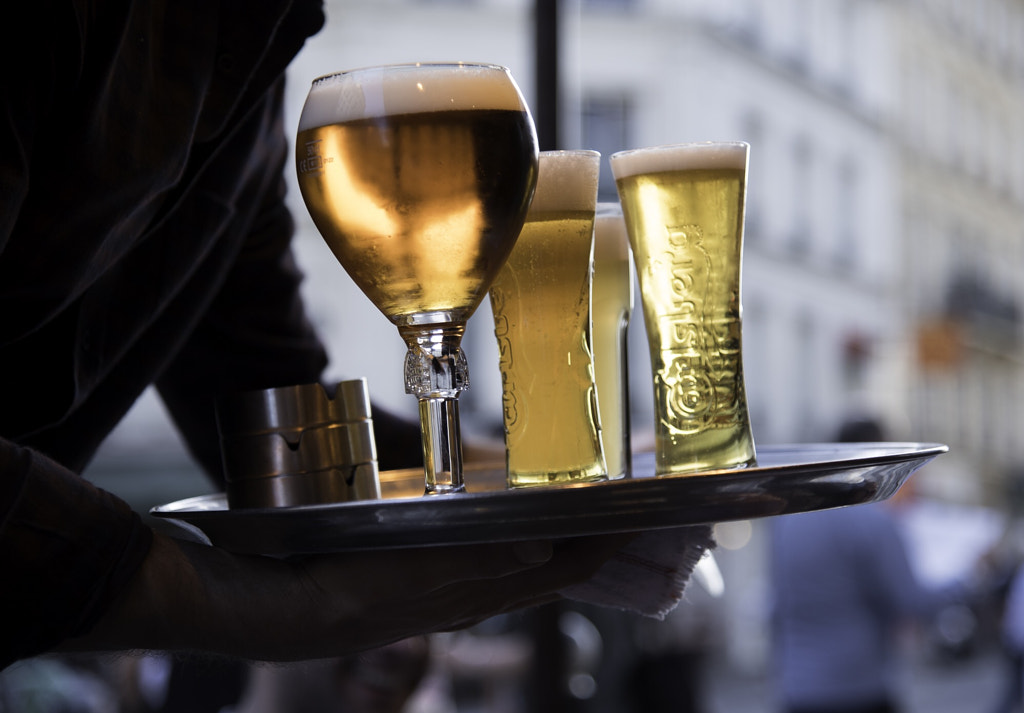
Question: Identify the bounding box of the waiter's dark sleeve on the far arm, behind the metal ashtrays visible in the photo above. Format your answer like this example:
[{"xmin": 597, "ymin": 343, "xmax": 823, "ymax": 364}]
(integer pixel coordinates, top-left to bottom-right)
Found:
[{"xmin": 157, "ymin": 82, "xmax": 327, "ymax": 480}]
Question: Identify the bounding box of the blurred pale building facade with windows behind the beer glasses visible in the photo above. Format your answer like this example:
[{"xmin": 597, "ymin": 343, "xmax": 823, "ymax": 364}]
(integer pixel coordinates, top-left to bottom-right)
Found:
[{"xmin": 276, "ymin": 0, "xmax": 1024, "ymax": 501}]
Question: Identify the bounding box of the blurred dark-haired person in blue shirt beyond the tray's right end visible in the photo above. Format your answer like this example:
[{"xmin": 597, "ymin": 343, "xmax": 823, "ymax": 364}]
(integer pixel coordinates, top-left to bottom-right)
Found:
[{"xmin": 771, "ymin": 420, "xmax": 961, "ymax": 713}]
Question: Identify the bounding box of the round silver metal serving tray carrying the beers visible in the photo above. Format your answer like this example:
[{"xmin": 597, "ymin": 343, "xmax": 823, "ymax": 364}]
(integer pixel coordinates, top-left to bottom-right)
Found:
[{"xmin": 150, "ymin": 442, "xmax": 949, "ymax": 554}]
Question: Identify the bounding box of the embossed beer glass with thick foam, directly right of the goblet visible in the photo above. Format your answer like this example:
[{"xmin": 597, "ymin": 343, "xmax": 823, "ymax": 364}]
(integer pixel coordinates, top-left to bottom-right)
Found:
[{"xmin": 490, "ymin": 151, "xmax": 607, "ymax": 488}]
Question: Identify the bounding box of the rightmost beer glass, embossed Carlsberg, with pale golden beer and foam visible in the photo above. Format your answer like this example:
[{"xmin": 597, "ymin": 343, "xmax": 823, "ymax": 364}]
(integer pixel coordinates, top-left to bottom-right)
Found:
[{"xmin": 611, "ymin": 142, "xmax": 755, "ymax": 474}]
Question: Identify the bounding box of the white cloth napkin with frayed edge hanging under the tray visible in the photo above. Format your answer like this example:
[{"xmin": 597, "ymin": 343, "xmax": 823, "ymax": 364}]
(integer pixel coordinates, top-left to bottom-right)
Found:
[{"xmin": 561, "ymin": 525, "xmax": 715, "ymax": 619}]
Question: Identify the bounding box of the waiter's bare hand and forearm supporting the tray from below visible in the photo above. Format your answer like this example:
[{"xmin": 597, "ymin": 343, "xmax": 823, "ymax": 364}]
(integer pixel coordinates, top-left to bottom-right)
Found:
[{"xmin": 61, "ymin": 534, "xmax": 629, "ymax": 661}]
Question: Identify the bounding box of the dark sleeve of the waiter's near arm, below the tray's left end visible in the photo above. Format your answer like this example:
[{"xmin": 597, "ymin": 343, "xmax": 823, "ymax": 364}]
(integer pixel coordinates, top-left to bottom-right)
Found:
[{"xmin": 0, "ymin": 439, "xmax": 153, "ymax": 667}]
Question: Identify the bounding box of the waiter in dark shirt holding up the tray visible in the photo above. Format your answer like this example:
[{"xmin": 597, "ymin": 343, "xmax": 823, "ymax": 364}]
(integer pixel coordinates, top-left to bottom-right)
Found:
[{"xmin": 0, "ymin": 0, "xmax": 623, "ymax": 684}]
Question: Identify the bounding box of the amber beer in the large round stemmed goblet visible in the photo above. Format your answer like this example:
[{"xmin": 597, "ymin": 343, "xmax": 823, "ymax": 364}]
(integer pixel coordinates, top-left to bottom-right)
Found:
[{"xmin": 296, "ymin": 67, "xmax": 537, "ymax": 326}]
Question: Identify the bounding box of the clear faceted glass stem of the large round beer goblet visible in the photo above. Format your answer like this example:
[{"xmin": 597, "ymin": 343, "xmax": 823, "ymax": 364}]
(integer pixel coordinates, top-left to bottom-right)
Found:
[{"xmin": 403, "ymin": 327, "xmax": 469, "ymax": 495}]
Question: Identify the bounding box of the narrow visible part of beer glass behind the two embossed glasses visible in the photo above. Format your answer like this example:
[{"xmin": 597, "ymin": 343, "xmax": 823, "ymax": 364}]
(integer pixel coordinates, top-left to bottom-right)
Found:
[{"xmin": 591, "ymin": 203, "xmax": 635, "ymax": 478}]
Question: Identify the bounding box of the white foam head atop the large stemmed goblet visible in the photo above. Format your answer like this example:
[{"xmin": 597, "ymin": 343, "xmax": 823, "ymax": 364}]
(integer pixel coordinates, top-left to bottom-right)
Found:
[{"xmin": 299, "ymin": 64, "xmax": 525, "ymax": 131}]
